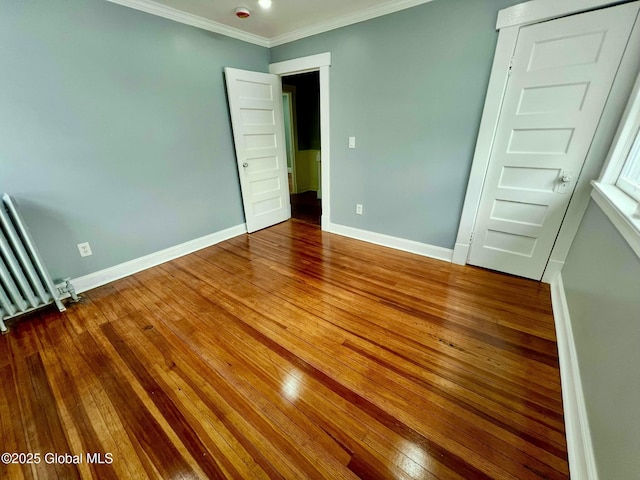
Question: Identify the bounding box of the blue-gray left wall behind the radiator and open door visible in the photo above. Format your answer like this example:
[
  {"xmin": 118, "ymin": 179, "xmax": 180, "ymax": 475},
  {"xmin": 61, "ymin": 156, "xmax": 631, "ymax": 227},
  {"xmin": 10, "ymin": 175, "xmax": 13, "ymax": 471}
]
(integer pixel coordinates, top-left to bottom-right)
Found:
[{"xmin": 0, "ymin": 0, "xmax": 269, "ymax": 277}]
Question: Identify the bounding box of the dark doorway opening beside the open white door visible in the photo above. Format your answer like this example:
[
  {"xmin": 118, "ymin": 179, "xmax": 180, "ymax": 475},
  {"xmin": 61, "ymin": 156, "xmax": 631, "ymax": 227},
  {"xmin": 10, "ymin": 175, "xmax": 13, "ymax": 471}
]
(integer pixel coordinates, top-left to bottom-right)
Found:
[{"xmin": 282, "ymin": 71, "xmax": 322, "ymax": 225}]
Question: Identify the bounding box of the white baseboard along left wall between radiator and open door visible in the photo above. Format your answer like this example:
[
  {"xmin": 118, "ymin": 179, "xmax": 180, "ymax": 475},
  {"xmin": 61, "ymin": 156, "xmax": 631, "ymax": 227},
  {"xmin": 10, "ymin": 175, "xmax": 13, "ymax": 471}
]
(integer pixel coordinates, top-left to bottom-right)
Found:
[{"xmin": 71, "ymin": 223, "xmax": 247, "ymax": 293}]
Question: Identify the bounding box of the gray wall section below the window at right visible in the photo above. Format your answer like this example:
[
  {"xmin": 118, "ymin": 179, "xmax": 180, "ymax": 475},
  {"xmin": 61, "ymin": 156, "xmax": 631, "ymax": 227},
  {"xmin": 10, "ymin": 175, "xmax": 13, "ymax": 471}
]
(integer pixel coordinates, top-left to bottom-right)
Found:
[{"xmin": 562, "ymin": 201, "xmax": 640, "ymax": 479}]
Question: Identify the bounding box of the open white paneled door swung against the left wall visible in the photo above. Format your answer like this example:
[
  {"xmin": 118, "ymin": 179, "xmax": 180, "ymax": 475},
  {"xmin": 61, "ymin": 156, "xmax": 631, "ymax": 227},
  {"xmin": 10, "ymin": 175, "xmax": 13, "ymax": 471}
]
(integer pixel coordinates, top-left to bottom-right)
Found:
[{"xmin": 224, "ymin": 68, "xmax": 291, "ymax": 233}]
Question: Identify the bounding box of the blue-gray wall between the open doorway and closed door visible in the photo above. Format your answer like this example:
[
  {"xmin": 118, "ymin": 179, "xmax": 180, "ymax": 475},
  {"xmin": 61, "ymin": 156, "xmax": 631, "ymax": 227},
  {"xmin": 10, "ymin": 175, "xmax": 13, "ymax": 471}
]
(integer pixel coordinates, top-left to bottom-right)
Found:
[{"xmin": 271, "ymin": 0, "xmax": 520, "ymax": 248}]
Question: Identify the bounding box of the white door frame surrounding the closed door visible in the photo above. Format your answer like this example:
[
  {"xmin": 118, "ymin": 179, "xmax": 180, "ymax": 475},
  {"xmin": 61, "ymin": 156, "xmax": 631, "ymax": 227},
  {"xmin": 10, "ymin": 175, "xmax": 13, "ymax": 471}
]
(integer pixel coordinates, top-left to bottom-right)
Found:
[{"xmin": 452, "ymin": 0, "xmax": 640, "ymax": 283}]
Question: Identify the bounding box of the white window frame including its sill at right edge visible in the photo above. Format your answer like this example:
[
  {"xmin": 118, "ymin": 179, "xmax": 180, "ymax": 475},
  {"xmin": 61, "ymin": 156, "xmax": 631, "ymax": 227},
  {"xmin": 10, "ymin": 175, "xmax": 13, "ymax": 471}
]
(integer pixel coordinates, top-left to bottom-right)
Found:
[{"xmin": 591, "ymin": 68, "xmax": 640, "ymax": 258}]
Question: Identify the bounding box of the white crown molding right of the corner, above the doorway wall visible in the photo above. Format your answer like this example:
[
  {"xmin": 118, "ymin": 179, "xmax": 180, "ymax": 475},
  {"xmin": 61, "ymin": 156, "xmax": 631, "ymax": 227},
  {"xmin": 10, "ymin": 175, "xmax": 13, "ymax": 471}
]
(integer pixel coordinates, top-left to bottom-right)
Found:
[{"xmin": 269, "ymin": 0, "xmax": 433, "ymax": 47}]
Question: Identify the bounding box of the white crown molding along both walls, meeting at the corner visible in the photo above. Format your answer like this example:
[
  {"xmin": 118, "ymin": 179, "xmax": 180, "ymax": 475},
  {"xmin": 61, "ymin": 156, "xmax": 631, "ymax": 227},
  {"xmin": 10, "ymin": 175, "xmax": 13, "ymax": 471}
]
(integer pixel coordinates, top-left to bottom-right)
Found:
[{"xmin": 107, "ymin": 0, "xmax": 433, "ymax": 47}]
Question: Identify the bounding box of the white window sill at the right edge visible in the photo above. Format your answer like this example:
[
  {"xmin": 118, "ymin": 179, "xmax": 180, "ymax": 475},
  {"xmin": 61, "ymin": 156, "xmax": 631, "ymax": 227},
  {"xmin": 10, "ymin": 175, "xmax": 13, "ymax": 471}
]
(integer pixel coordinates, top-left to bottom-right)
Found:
[{"xmin": 591, "ymin": 181, "xmax": 640, "ymax": 258}]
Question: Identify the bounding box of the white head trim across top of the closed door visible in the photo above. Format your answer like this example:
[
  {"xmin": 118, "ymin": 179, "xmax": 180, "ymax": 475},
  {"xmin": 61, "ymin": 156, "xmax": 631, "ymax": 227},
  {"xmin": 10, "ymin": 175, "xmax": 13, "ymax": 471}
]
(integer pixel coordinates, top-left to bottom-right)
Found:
[{"xmin": 496, "ymin": 0, "xmax": 625, "ymax": 30}]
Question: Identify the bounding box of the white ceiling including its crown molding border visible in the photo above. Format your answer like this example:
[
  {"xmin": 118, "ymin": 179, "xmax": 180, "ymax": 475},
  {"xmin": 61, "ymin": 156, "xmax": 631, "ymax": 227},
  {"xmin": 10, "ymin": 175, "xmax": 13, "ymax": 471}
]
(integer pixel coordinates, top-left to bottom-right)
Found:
[{"xmin": 108, "ymin": 0, "xmax": 431, "ymax": 47}]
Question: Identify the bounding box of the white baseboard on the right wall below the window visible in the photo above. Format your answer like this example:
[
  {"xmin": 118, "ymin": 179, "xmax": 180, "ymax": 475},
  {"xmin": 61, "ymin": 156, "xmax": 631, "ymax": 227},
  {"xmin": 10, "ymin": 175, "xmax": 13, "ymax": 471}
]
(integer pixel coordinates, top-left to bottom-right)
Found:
[{"xmin": 551, "ymin": 274, "xmax": 598, "ymax": 480}]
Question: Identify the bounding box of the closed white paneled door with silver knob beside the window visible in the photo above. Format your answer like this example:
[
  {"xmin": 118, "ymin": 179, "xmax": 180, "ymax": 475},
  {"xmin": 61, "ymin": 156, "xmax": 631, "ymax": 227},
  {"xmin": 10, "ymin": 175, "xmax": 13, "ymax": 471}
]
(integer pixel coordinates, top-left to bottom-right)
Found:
[{"xmin": 468, "ymin": 2, "xmax": 639, "ymax": 280}]
